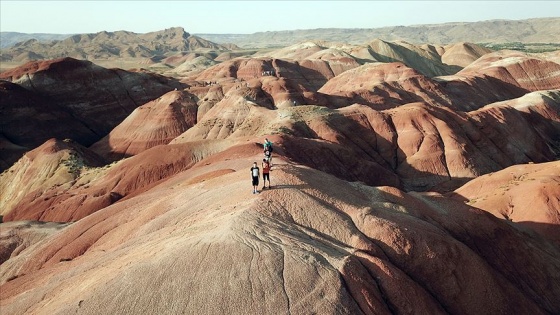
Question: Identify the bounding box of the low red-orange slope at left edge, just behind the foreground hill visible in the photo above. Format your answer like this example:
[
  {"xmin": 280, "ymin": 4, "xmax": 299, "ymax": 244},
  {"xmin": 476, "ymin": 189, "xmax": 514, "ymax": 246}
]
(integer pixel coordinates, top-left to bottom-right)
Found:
[{"xmin": 2, "ymin": 144, "xmax": 202, "ymax": 222}]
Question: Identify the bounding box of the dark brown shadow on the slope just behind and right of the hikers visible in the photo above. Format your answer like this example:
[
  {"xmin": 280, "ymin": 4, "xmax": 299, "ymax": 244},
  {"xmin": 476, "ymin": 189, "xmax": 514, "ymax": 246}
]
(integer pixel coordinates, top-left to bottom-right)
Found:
[{"xmin": 283, "ymin": 113, "xmax": 486, "ymax": 193}]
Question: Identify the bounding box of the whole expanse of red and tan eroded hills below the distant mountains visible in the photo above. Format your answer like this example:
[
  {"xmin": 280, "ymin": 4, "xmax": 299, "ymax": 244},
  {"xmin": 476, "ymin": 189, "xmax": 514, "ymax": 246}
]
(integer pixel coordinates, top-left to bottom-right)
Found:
[{"xmin": 0, "ymin": 23, "xmax": 560, "ymax": 315}]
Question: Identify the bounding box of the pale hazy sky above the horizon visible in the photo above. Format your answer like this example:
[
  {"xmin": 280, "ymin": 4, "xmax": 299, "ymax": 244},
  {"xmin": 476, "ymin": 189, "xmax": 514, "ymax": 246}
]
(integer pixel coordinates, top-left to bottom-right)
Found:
[{"xmin": 0, "ymin": 0, "xmax": 560, "ymax": 34}]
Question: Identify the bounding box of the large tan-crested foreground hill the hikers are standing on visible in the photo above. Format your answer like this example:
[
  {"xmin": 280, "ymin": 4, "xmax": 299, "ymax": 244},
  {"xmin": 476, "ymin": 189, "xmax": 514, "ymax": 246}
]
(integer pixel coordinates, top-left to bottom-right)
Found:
[{"xmin": 0, "ymin": 152, "xmax": 560, "ymax": 314}]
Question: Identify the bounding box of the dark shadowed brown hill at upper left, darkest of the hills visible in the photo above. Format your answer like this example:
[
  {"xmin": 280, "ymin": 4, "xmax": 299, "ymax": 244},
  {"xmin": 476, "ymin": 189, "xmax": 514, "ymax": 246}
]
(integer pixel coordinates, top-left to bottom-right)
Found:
[{"xmin": 0, "ymin": 58, "xmax": 185, "ymax": 169}]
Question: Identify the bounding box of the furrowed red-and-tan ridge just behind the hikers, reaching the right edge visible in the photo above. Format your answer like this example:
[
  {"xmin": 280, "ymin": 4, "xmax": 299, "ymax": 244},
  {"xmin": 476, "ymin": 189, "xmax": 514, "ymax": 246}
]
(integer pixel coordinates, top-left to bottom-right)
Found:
[{"xmin": 171, "ymin": 90, "xmax": 560, "ymax": 191}]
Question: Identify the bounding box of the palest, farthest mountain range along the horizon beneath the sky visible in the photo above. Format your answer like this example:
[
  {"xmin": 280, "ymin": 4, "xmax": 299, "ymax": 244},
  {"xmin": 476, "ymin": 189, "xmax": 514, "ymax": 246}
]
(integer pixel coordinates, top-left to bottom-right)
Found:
[{"xmin": 4, "ymin": 17, "xmax": 560, "ymax": 49}]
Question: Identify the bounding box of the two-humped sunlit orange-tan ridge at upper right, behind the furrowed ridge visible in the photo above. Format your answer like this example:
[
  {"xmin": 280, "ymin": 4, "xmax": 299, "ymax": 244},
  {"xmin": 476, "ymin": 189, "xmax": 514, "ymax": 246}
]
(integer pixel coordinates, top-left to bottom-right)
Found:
[{"xmin": 318, "ymin": 51, "xmax": 560, "ymax": 112}]
